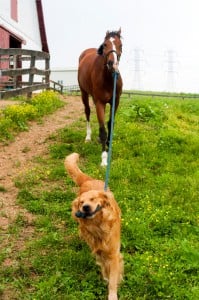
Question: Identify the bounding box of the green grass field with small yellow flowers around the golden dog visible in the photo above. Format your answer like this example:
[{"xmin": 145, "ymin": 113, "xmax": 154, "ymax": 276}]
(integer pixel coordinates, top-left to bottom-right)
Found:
[{"xmin": 0, "ymin": 96, "xmax": 199, "ymax": 300}]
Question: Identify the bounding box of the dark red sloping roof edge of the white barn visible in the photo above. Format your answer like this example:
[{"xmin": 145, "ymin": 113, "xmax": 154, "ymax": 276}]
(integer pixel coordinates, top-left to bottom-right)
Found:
[{"xmin": 35, "ymin": 0, "xmax": 49, "ymax": 53}]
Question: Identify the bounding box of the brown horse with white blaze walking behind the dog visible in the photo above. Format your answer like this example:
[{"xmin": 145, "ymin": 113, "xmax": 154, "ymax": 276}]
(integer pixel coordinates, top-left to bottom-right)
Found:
[{"xmin": 78, "ymin": 29, "xmax": 122, "ymax": 166}]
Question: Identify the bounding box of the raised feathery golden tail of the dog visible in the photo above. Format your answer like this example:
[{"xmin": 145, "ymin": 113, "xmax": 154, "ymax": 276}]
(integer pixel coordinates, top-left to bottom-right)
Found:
[{"xmin": 64, "ymin": 153, "xmax": 92, "ymax": 186}]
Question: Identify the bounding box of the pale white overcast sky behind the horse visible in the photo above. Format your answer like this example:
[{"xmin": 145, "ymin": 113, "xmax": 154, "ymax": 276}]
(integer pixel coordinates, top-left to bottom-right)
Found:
[{"xmin": 42, "ymin": 0, "xmax": 199, "ymax": 93}]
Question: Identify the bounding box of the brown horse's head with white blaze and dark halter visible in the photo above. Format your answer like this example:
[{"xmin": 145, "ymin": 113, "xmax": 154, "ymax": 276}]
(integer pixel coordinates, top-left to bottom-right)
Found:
[{"xmin": 97, "ymin": 28, "xmax": 122, "ymax": 72}]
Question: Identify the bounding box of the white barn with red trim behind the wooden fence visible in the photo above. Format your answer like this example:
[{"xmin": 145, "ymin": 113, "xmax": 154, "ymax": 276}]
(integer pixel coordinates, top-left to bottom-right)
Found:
[{"xmin": 0, "ymin": 0, "xmax": 49, "ymax": 88}]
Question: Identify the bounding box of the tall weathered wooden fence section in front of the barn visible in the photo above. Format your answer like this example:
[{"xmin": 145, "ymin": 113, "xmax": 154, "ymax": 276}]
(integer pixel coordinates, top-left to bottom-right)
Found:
[{"xmin": 0, "ymin": 48, "xmax": 50, "ymax": 99}]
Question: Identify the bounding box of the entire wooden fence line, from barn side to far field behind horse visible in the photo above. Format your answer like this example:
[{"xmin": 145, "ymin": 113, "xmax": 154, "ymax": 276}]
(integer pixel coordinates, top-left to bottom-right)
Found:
[{"xmin": 0, "ymin": 48, "xmax": 199, "ymax": 99}]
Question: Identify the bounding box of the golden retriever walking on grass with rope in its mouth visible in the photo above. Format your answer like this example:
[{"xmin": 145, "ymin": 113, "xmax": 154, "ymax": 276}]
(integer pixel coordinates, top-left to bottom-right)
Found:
[{"xmin": 64, "ymin": 153, "xmax": 123, "ymax": 300}]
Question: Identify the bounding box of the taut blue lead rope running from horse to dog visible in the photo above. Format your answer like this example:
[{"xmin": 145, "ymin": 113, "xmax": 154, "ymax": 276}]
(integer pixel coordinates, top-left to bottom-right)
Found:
[{"xmin": 104, "ymin": 71, "xmax": 119, "ymax": 192}]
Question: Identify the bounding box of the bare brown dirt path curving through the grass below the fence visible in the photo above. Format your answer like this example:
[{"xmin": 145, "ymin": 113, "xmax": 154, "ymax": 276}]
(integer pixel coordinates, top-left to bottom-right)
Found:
[{"xmin": 0, "ymin": 96, "xmax": 83, "ymax": 231}]
